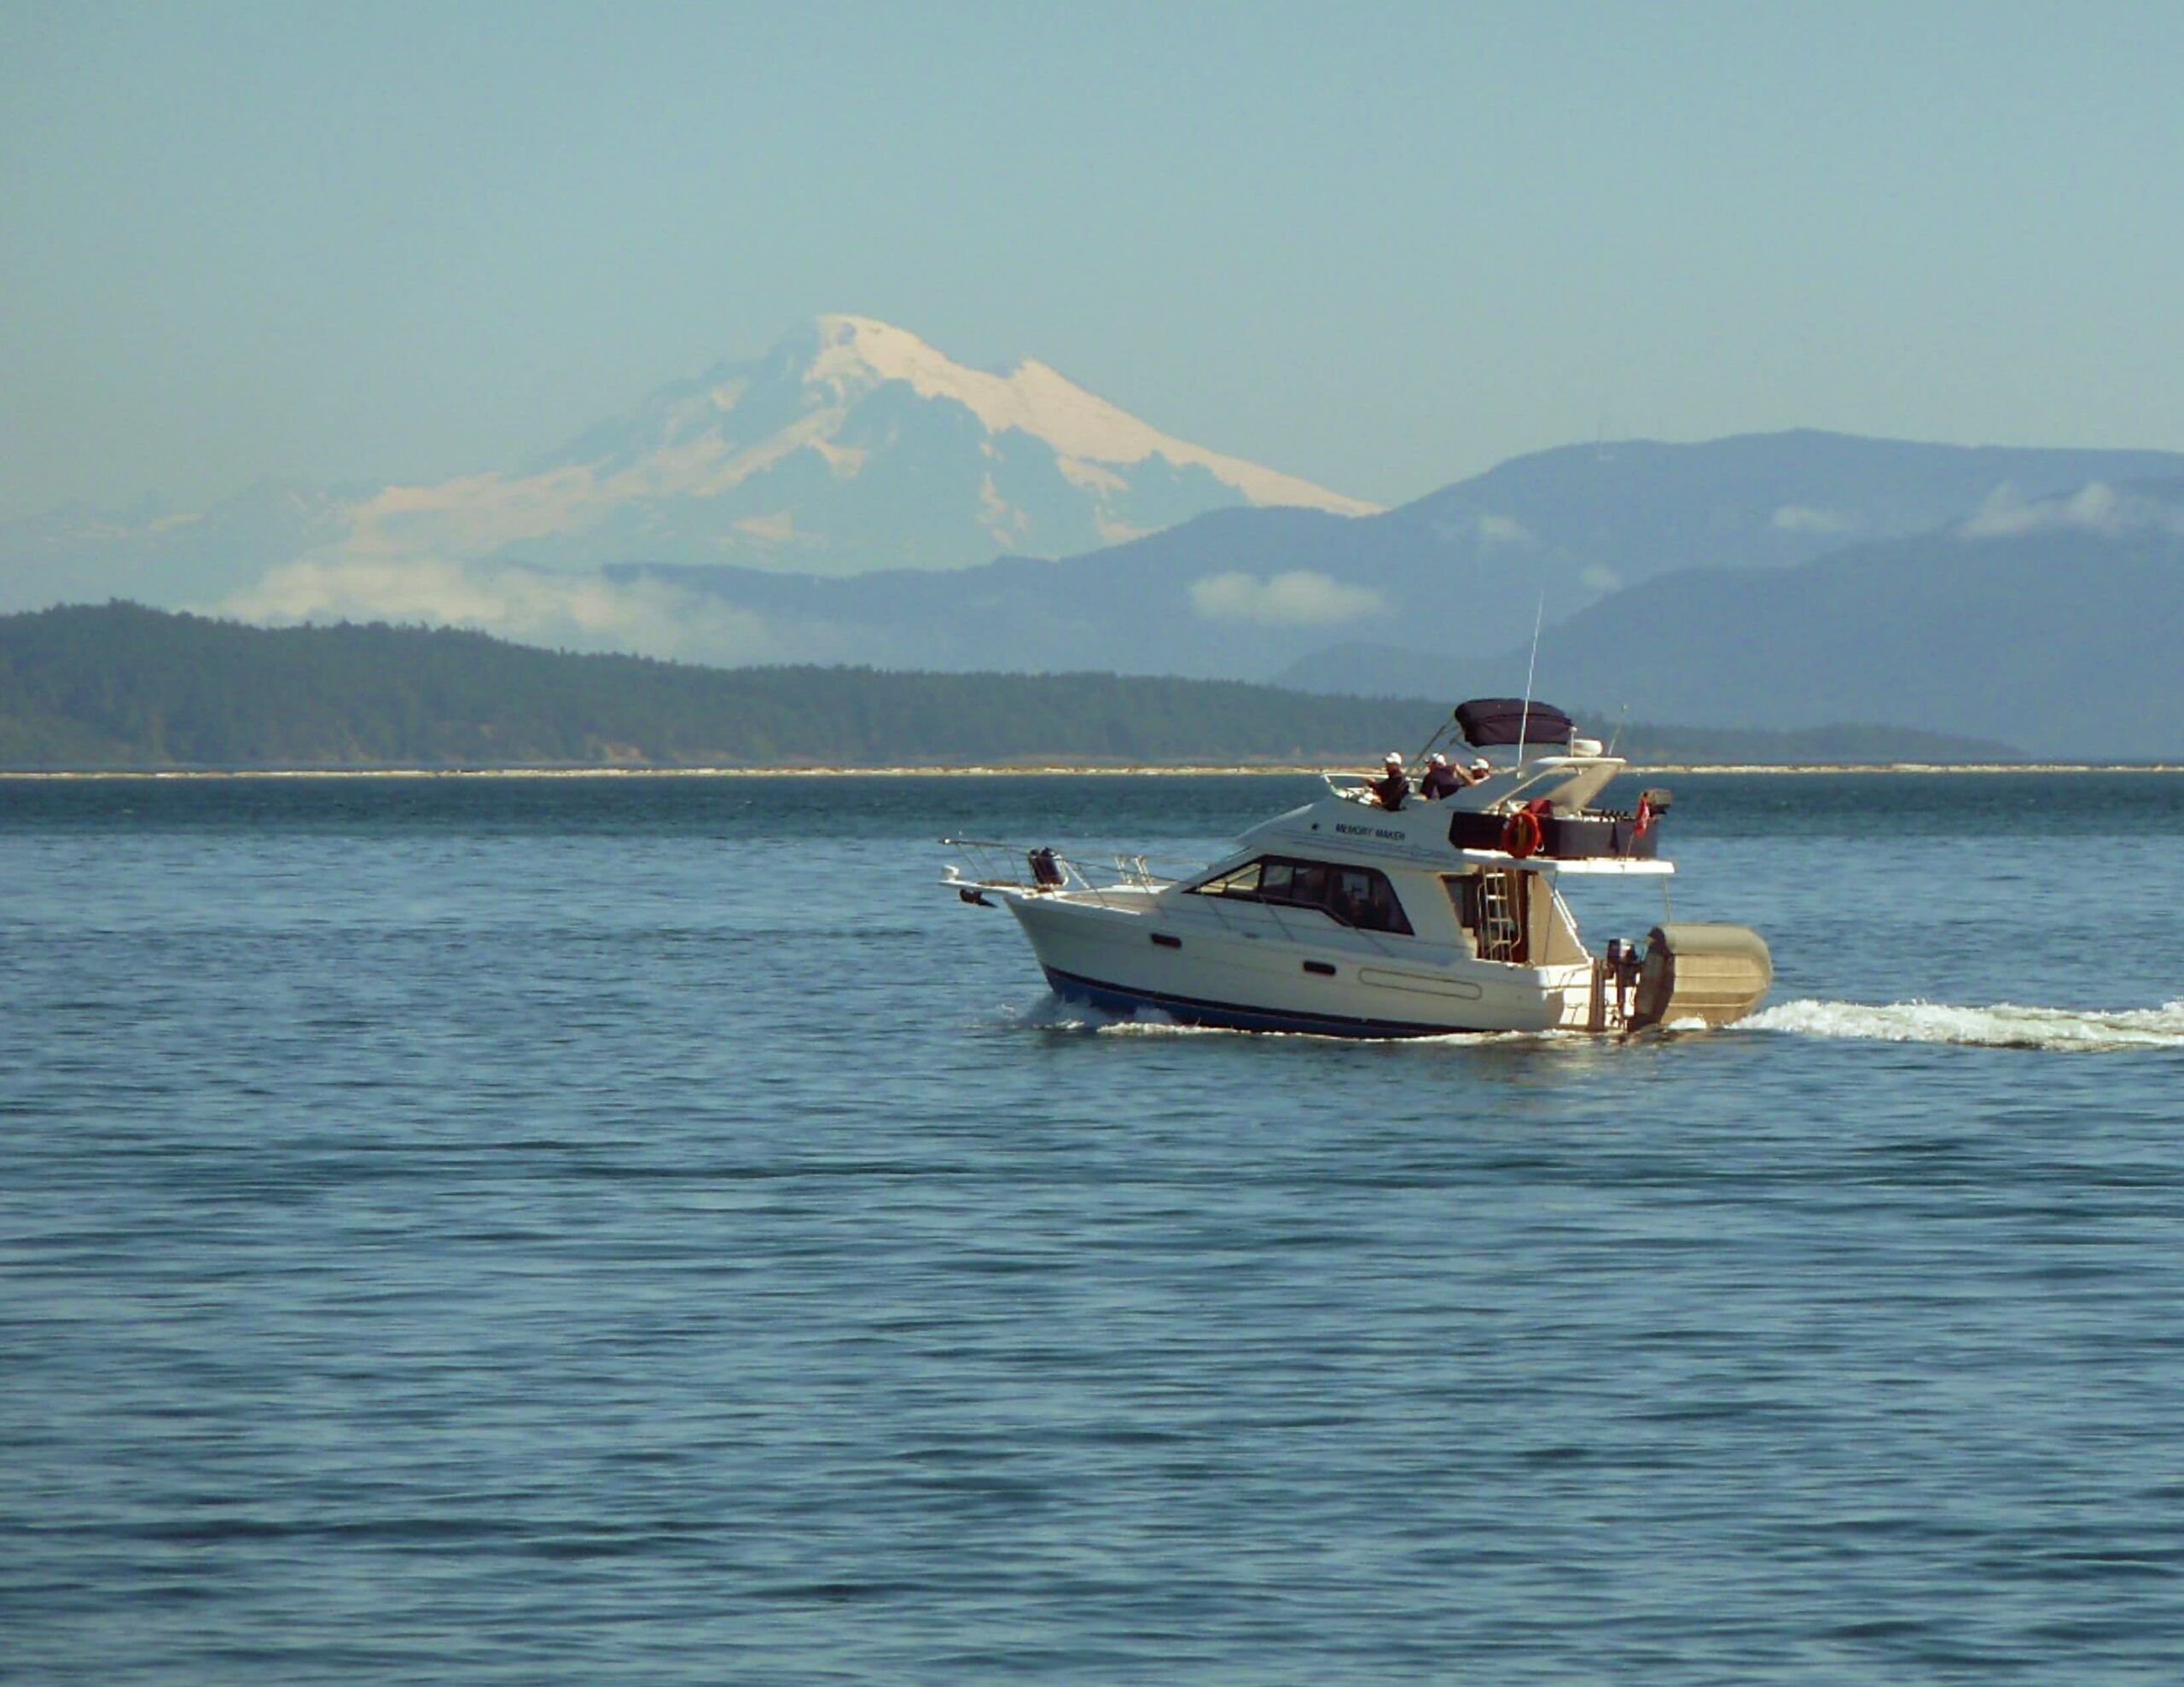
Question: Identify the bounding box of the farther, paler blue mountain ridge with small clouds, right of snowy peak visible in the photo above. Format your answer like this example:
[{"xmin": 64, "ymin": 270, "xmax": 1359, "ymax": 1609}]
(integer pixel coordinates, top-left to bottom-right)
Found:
[{"xmin": 633, "ymin": 432, "xmax": 2184, "ymax": 702}]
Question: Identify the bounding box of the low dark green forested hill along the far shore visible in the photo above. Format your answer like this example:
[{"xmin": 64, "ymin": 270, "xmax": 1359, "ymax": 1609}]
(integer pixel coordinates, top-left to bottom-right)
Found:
[{"xmin": 0, "ymin": 602, "xmax": 2009, "ymax": 770}]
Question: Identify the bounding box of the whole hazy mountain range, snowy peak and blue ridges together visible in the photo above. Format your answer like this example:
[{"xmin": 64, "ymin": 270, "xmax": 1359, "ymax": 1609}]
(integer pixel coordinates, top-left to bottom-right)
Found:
[{"xmin": 0, "ymin": 316, "xmax": 2184, "ymax": 757}]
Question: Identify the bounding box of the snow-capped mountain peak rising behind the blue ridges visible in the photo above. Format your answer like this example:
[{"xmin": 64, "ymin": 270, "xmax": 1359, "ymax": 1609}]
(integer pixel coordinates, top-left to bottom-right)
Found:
[{"xmin": 0, "ymin": 316, "xmax": 1372, "ymax": 606}]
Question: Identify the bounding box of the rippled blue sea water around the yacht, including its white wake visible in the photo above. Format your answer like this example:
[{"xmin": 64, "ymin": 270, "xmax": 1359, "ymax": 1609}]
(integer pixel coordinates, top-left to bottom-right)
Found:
[{"xmin": 0, "ymin": 774, "xmax": 2184, "ymax": 1684}]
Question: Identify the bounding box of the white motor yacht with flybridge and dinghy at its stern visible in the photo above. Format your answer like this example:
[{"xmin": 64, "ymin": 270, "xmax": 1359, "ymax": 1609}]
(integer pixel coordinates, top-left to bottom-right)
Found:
[{"xmin": 945, "ymin": 699, "xmax": 1774, "ymax": 1036}]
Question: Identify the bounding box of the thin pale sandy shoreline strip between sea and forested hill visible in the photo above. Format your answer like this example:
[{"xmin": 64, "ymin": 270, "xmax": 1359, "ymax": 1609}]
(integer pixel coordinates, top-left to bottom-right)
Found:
[{"xmin": 0, "ymin": 762, "xmax": 2184, "ymax": 781}]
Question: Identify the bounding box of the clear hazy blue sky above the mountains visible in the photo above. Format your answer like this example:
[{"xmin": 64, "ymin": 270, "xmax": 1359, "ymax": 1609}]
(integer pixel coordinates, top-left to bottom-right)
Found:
[{"xmin": 0, "ymin": 0, "xmax": 2184, "ymax": 515}]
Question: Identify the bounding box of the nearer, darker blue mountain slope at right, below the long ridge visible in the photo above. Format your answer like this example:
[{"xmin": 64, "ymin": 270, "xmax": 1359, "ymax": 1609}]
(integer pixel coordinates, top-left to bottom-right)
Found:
[{"xmin": 1459, "ymin": 480, "xmax": 2184, "ymax": 759}]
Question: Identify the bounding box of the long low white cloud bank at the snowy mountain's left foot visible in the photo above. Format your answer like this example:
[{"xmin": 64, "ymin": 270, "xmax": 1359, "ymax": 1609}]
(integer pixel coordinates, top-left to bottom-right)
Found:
[{"xmin": 214, "ymin": 559, "xmax": 791, "ymax": 665}]
